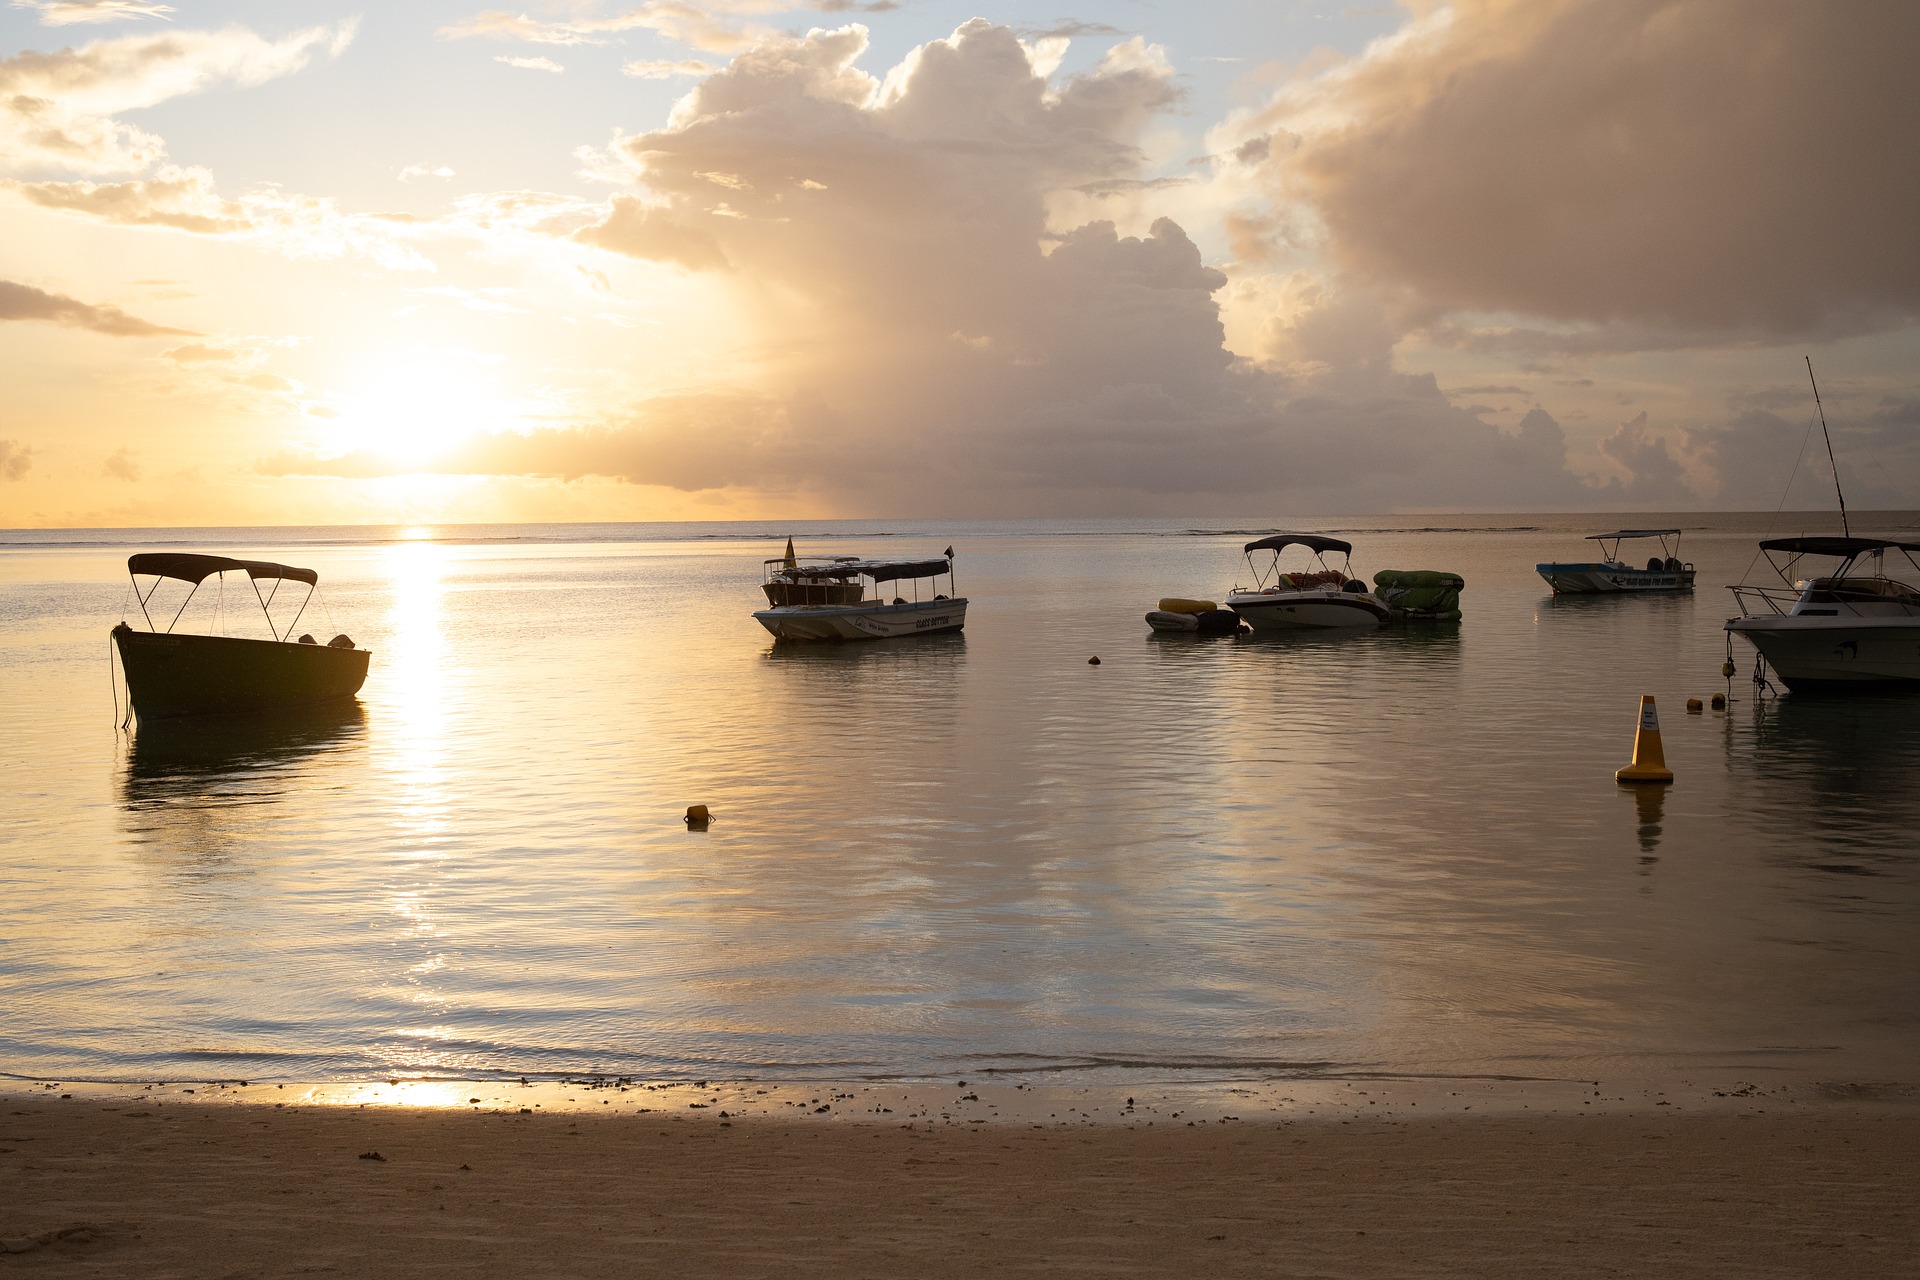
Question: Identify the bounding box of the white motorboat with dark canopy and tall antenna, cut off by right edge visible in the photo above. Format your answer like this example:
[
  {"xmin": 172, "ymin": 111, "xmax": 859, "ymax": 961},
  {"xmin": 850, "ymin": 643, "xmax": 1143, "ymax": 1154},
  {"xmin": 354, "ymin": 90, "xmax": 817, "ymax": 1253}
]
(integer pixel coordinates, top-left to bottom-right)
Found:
[{"xmin": 1726, "ymin": 537, "xmax": 1920, "ymax": 689}]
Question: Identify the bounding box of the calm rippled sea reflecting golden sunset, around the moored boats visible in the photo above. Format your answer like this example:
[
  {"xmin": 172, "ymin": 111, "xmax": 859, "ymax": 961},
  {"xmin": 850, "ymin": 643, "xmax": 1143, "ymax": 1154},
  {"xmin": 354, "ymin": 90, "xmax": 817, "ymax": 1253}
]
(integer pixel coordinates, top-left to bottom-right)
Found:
[{"xmin": 0, "ymin": 514, "xmax": 1920, "ymax": 1080}]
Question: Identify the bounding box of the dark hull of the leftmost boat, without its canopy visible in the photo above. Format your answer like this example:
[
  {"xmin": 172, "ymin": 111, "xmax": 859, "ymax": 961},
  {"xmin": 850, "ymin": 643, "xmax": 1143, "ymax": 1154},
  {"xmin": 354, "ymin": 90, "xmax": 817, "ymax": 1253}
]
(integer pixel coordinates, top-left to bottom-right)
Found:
[{"xmin": 113, "ymin": 624, "xmax": 372, "ymax": 720}]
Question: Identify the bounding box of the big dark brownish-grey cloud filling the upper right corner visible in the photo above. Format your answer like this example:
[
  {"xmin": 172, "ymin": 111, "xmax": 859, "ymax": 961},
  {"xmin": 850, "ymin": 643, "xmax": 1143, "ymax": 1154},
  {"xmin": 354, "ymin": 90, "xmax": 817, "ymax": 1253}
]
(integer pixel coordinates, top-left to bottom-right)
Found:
[{"xmin": 1235, "ymin": 0, "xmax": 1920, "ymax": 351}]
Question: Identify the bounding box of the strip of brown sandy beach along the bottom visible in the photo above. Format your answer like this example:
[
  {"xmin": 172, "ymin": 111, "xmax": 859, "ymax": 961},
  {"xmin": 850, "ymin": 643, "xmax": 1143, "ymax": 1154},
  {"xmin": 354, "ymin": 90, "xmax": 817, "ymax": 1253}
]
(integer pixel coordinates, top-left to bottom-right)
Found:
[{"xmin": 0, "ymin": 1094, "xmax": 1920, "ymax": 1280}]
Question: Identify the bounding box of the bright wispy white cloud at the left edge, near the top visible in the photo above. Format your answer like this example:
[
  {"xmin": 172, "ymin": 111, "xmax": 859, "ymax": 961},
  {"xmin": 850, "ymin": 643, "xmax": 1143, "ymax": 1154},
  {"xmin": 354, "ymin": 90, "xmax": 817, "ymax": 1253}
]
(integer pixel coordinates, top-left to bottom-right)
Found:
[{"xmin": 0, "ymin": 21, "xmax": 355, "ymax": 175}]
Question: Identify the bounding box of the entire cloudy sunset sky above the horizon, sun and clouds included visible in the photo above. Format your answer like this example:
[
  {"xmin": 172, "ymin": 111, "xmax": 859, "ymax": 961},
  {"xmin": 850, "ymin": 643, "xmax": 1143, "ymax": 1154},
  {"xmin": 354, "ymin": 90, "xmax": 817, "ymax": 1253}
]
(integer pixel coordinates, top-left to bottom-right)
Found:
[{"xmin": 0, "ymin": 0, "xmax": 1920, "ymax": 528}]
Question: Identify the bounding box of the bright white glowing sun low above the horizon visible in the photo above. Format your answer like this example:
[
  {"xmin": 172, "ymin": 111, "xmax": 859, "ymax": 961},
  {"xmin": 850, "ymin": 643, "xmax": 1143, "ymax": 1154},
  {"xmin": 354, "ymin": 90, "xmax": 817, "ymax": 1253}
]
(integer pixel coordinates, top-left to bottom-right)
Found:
[{"xmin": 326, "ymin": 349, "xmax": 524, "ymax": 466}]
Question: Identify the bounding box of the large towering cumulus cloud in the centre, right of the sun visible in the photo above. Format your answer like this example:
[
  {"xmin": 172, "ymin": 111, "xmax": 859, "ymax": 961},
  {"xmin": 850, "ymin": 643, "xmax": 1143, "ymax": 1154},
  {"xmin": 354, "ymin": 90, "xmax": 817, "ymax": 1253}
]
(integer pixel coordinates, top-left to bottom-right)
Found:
[{"xmin": 374, "ymin": 21, "xmax": 1635, "ymax": 514}]
